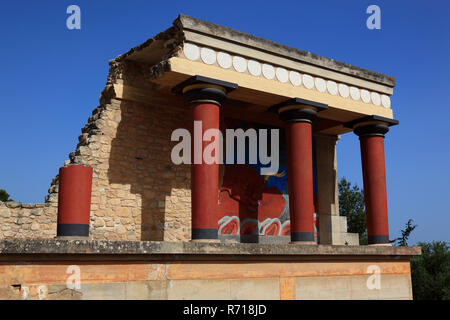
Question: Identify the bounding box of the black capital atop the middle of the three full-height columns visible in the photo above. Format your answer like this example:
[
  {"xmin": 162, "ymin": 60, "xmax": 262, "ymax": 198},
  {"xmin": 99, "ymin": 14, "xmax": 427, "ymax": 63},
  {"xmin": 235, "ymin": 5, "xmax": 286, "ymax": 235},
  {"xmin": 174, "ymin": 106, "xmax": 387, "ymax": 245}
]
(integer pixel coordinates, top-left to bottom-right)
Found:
[{"xmin": 269, "ymin": 98, "xmax": 328, "ymax": 123}]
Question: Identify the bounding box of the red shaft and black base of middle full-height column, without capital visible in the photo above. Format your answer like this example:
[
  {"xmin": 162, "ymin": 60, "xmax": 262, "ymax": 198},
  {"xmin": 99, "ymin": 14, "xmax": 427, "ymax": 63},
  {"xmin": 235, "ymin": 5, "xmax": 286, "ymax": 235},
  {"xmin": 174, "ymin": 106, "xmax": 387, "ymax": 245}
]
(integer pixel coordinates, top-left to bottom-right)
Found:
[{"xmin": 285, "ymin": 122, "xmax": 314, "ymax": 243}]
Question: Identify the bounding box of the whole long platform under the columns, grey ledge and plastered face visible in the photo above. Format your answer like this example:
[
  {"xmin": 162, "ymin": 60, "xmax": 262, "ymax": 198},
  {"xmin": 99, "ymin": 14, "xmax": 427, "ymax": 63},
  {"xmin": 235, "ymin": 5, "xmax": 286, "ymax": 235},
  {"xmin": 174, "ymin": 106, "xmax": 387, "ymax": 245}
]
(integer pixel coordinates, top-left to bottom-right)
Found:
[{"xmin": 0, "ymin": 240, "xmax": 420, "ymax": 300}]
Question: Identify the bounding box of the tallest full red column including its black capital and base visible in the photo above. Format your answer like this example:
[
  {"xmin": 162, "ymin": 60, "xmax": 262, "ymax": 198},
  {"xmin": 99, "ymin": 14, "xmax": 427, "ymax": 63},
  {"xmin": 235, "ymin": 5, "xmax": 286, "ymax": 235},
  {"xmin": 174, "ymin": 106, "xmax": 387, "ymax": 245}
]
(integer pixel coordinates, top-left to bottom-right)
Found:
[{"xmin": 172, "ymin": 76, "xmax": 237, "ymax": 241}]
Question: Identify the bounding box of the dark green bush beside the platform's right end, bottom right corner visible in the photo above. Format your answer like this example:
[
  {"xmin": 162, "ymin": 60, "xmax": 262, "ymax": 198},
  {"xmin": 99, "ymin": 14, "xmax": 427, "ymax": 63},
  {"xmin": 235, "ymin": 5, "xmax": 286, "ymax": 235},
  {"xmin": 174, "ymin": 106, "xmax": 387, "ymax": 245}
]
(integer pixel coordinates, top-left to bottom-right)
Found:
[{"xmin": 411, "ymin": 241, "xmax": 450, "ymax": 300}]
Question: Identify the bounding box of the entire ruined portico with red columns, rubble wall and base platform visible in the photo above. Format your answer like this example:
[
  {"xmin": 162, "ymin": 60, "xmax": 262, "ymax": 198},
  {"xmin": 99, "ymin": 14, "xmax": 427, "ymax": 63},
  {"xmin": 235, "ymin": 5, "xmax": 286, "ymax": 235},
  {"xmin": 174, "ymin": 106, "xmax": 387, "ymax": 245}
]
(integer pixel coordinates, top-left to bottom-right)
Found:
[{"xmin": 0, "ymin": 15, "xmax": 420, "ymax": 299}]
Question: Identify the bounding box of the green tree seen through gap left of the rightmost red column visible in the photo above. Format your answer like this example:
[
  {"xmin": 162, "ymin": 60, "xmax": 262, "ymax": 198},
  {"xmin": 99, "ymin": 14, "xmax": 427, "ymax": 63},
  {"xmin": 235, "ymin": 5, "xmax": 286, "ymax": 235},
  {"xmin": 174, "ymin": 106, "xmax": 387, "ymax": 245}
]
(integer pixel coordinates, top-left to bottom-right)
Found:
[{"xmin": 338, "ymin": 177, "xmax": 367, "ymax": 245}]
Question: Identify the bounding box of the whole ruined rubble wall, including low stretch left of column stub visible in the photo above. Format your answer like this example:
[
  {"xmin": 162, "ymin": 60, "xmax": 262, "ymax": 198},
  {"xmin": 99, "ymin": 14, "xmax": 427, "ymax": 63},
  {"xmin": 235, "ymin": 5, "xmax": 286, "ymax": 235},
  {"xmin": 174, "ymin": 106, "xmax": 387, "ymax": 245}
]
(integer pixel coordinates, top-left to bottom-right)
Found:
[{"xmin": 0, "ymin": 48, "xmax": 191, "ymax": 241}]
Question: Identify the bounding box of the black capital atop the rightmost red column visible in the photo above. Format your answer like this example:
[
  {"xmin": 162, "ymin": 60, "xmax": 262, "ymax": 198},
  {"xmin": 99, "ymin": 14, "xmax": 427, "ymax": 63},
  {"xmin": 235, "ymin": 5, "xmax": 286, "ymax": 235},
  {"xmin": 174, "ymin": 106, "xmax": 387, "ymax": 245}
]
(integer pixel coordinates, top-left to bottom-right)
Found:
[{"xmin": 344, "ymin": 115, "xmax": 399, "ymax": 138}]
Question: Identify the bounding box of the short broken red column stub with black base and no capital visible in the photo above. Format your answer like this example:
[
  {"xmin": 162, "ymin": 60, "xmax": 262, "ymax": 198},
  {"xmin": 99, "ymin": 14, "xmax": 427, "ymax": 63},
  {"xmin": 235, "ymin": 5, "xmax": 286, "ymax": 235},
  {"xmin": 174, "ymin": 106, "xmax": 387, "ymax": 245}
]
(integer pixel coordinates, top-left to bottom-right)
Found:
[{"xmin": 57, "ymin": 165, "xmax": 92, "ymax": 237}]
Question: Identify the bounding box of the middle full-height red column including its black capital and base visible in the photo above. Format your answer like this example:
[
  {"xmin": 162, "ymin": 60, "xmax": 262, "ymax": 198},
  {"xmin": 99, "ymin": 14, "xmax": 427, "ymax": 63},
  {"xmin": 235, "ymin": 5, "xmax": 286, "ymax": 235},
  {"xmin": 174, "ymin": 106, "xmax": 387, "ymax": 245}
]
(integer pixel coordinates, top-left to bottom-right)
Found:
[{"xmin": 272, "ymin": 98, "xmax": 328, "ymax": 244}]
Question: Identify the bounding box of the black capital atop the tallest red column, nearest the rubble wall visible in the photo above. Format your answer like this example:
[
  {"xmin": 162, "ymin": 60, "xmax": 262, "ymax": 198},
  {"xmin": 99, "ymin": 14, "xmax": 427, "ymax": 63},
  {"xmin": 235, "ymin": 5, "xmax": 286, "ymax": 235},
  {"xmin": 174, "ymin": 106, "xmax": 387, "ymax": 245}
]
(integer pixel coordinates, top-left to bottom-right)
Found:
[{"xmin": 172, "ymin": 75, "xmax": 238, "ymax": 106}]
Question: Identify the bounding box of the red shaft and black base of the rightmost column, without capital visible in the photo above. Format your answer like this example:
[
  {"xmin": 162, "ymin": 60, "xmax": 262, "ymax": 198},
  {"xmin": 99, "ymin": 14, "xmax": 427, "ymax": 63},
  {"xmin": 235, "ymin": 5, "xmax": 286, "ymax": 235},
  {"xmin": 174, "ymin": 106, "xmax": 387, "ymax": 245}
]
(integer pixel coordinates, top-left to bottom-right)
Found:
[{"xmin": 360, "ymin": 135, "xmax": 389, "ymax": 244}]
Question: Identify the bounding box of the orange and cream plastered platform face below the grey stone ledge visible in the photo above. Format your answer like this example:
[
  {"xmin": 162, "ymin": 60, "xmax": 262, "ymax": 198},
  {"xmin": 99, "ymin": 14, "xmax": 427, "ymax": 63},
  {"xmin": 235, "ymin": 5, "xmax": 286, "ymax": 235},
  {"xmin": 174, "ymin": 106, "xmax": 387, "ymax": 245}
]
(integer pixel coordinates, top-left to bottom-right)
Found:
[{"xmin": 0, "ymin": 260, "xmax": 412, "ymax": 300}]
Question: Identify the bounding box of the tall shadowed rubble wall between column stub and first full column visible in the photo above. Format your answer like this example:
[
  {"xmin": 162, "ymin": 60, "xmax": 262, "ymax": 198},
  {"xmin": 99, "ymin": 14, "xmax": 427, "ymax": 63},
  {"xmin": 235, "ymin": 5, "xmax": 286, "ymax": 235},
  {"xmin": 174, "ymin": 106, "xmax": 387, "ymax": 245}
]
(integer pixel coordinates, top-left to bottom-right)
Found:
[{"xmin": 75, "ymin": 99, "xmax": 190, "ymax": 241}]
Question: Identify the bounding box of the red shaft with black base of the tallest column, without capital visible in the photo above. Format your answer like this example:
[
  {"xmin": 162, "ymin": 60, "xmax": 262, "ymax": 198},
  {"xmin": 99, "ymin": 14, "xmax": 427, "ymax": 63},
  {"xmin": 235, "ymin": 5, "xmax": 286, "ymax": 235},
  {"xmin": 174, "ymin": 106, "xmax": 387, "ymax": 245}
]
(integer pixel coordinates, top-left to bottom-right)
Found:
[{"xmin": 191, "ymin": 103, "xmax": 220, "ymax": 240}]
